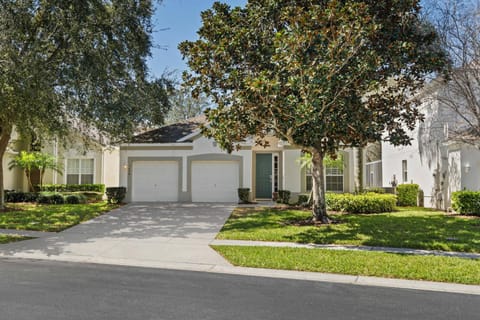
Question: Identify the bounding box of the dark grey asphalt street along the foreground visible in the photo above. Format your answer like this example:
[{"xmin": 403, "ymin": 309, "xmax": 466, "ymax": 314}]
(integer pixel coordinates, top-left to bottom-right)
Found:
[{"xmin": 0, "ymin": 259, "xmax": 480, "ymax": 320}]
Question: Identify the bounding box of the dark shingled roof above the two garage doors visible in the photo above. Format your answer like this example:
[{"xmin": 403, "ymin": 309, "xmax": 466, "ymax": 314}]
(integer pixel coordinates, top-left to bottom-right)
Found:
[{"xmin": 130, "ymin": 115, "xmax": 206, "ymax": 143}]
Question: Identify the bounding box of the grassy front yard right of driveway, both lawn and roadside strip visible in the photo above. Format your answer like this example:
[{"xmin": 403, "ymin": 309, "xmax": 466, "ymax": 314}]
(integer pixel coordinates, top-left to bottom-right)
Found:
[{"xmin": 213, "ymin": 208, "xmax": 480, "ymax": 285}]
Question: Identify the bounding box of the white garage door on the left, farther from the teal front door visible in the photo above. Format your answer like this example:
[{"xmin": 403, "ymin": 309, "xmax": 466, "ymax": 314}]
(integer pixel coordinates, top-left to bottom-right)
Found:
[{"xmin": 132, "ymin": 161, "xmax": 179, "ymax": 202}]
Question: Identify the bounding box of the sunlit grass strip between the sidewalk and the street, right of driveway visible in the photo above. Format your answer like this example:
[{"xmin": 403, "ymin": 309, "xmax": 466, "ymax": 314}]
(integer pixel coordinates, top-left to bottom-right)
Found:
[{"xmin": 212, "ymin": 246, "xmax": 480, "ymax": 285}]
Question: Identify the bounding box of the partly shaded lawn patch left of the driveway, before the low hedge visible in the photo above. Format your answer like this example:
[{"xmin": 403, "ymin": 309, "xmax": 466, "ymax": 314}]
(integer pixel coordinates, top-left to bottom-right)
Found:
[{"xmin": 0, "ymin": 202, "xmax": 118, "ymax": 232}]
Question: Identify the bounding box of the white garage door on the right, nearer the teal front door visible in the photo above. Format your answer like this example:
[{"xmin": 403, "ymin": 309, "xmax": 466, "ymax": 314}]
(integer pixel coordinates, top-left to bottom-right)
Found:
[{"xmin": 192, "ymin": 161, "xmax": 239, "ymax": 202}]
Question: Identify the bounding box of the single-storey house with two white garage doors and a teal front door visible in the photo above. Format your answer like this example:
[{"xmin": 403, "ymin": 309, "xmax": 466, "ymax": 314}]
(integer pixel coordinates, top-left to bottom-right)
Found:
[{"xmin": 120, "ymin": 116, "xmax": 354, "ymax": 202}]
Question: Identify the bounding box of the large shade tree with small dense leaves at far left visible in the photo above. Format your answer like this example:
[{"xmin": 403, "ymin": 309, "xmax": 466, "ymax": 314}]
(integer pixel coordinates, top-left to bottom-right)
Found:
[{"xmin": 0, "ymin": 0, "xmax": 172, "ymax": 209}]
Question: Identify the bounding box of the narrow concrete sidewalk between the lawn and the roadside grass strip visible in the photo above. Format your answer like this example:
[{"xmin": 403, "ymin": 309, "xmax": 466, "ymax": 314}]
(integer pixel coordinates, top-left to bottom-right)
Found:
[{"xmin": 210, "ymin": 240, "xmax": 480, "ymax": 259}]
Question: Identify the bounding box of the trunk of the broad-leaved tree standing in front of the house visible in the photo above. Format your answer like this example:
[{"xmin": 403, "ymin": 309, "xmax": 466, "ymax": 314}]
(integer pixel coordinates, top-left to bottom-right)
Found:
[{"xmin": 311, "ymin": 149, "xmax": 330, "ymax": 223}]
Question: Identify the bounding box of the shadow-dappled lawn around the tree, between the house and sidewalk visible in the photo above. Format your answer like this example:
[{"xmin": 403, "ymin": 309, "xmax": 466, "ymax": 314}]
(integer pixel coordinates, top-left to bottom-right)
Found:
[{"xmin": 217, "ymin": 208, "xmax": 480, "ymax": 252}]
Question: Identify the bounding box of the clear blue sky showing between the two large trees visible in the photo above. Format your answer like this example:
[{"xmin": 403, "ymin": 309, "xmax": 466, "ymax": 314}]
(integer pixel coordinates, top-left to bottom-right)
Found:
[{"xmin": 148, "ymin": 0, "xmax": 247, "ymax": 78}]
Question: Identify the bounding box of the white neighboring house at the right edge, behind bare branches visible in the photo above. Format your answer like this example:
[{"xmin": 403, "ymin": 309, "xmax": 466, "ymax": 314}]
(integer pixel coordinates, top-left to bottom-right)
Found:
[{"xmin": 382, "ymin": 82, "xmax": 480, "ymax": 210}]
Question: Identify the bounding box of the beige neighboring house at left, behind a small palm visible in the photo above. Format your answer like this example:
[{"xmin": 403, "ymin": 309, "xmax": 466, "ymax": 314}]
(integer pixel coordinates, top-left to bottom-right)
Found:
[{"xmin": 3, "ymin": 128, "xmax": 120, "ymax": 191}]
